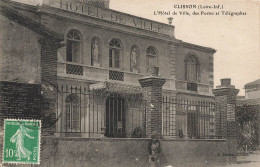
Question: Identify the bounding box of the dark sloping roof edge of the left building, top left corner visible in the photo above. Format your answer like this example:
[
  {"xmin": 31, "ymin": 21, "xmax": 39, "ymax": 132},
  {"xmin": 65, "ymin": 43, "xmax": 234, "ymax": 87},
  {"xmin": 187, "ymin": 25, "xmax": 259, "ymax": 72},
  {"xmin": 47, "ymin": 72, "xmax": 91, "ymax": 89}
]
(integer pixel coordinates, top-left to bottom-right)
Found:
[{"xmin": 0, "ymin": 0, "xmax": 64, "ymax": 42}]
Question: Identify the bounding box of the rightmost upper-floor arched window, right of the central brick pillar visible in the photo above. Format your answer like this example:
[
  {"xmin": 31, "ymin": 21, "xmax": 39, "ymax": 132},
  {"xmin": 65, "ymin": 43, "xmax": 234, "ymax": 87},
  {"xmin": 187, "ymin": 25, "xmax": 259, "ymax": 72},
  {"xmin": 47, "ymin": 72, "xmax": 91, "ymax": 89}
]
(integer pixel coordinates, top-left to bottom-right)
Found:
[{"xmin": 185, "ymin": 55, "xmax": 199, "ymax": 82}]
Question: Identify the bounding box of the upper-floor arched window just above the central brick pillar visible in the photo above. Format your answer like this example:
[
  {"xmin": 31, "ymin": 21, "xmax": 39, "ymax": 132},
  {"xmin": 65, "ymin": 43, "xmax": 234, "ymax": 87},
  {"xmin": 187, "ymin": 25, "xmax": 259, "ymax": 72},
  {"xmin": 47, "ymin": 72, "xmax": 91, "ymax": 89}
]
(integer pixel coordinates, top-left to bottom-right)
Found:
[{"xmin": 146, "ymin": 46, "xmax": 157, "ymax": 72}]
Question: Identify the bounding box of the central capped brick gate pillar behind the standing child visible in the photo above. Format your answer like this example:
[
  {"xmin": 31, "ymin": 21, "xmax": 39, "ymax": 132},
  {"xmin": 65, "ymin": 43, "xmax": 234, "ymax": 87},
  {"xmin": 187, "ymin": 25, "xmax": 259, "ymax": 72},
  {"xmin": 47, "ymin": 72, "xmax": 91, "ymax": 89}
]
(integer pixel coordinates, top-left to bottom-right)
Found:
[{"xmin": 139, "ymin": 76, "xmax": 166, "ymax": 137}]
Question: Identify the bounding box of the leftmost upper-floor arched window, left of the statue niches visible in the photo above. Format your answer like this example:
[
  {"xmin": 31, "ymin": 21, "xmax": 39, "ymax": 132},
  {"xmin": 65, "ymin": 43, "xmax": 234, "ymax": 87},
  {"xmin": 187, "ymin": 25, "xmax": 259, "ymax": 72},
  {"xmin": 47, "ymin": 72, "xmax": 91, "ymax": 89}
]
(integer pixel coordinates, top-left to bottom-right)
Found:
[{"xmin": 66, "ymin": 30, "xmax": 82, "ymax": 63}]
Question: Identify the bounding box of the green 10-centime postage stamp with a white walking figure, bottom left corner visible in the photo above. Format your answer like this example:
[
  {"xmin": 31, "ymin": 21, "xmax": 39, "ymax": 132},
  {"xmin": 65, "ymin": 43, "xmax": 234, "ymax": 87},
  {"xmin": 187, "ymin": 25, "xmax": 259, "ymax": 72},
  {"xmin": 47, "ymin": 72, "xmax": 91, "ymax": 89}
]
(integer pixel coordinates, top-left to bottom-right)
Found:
[{"xmin": 3, "ymin": 119, "xmax": 41, "ymax": 164}]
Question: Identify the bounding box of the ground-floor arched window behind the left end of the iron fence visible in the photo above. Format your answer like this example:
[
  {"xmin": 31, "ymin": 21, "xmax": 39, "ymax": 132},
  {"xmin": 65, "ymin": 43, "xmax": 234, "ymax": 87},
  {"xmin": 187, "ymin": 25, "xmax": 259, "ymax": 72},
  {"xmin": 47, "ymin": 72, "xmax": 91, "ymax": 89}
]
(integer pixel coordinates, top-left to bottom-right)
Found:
[{"xmin": 65, "ymin": 94, "xmax": 80, "ymax": 132}]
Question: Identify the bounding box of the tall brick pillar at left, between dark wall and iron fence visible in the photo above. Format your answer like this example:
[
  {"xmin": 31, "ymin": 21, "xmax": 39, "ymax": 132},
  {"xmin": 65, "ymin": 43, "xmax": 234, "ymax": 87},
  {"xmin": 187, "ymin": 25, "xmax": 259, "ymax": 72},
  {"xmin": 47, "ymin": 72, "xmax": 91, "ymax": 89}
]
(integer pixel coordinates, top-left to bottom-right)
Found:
[{"xmin": 39, "ymin": 38, "xmax": 62, "ymax": 135}]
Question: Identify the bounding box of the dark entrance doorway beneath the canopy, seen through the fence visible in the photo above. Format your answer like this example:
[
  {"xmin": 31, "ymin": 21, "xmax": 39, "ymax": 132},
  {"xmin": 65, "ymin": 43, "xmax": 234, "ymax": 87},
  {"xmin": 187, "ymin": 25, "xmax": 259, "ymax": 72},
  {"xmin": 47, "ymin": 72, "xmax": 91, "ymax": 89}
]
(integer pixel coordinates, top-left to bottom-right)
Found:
[{"xmin": 105, "ymin": 96, "xmax": 126, "ymax": 137}]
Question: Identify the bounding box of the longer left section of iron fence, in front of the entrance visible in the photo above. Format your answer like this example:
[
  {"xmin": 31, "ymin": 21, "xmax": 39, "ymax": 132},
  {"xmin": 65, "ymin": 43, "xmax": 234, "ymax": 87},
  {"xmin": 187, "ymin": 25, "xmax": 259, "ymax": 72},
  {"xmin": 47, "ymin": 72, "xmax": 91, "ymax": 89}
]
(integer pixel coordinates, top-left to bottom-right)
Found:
[{"xmin": 56, "ymin": 85, "xmax": 146, "ymax": 137}]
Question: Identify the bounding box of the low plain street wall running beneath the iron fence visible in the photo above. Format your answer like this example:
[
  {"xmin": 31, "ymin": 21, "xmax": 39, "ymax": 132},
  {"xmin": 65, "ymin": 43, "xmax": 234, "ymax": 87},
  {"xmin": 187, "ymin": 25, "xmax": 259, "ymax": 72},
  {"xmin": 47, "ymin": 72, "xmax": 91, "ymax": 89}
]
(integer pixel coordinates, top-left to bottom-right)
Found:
[{"xmin": 0, "ymin": 137, "xmax": 236, "ymax": 167}]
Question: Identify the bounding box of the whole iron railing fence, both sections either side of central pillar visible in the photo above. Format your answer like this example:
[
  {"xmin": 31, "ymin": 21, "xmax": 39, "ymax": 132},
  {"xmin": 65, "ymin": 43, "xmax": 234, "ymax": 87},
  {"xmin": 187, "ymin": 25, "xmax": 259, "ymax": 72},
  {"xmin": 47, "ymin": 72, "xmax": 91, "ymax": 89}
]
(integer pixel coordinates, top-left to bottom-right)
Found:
[{"xmin": 56, "ymin": 85, "xmax": 222, "ymax": 139}]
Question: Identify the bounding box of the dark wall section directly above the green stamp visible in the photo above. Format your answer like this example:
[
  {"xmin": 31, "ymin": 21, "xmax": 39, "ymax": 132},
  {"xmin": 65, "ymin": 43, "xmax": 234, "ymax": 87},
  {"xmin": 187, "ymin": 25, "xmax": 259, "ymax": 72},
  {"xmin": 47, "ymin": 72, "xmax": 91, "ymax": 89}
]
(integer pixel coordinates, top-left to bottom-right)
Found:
[{"xmin": 0, "ymin": 81, "xmax": 41, "ymax": 132}]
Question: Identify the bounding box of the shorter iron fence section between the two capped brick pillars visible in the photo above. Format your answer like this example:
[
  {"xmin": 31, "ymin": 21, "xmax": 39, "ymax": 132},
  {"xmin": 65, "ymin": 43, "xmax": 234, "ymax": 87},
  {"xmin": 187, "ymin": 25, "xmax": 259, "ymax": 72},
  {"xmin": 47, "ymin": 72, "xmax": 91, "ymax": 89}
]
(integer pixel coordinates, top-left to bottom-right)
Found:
[{"xmin": 162, "ymin": 97, "xmax": 223, "ymax": 139}]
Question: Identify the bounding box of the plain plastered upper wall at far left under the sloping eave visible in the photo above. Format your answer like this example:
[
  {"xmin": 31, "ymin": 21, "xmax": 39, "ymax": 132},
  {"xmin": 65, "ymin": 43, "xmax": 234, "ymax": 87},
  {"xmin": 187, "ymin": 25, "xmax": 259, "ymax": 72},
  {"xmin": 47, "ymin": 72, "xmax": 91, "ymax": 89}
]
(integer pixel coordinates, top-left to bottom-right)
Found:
[{"xmin": 0, "ymin": 15, "xmax": 41, "ymax": 84}]
